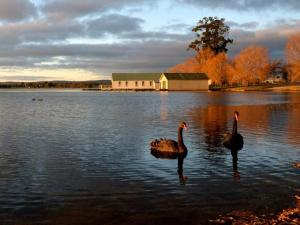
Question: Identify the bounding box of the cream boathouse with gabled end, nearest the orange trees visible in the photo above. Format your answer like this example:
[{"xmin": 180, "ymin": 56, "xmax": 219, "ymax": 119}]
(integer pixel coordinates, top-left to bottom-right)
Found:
[{"xmin": 159, "ymin": 73, "xmax": 210, "ymax": 91}]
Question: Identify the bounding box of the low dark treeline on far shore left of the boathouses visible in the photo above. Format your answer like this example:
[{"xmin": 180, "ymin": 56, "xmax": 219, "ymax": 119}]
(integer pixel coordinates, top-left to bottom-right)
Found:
[{"xmin": 0, "ymin": 80, "xmax": 111, "ymax": 88}]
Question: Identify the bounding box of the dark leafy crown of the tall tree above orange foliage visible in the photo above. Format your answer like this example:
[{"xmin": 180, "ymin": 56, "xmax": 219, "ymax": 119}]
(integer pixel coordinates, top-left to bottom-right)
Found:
[{"xmin": 188, "ymin": 17, "xmax": 233, "ymax": 54}]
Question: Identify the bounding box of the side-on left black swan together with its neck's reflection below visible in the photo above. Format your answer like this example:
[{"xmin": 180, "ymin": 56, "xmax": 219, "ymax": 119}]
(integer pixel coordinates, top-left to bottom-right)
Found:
[{"xmin": 150, "ymin": 122, "xmax": 188, "ymax": 184}]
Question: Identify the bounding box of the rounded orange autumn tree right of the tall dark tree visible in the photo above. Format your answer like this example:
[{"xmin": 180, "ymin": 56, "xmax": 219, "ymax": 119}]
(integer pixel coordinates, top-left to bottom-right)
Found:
[{"xmin": 227, "ymin": 46, "xmax": 269, "ymax": 84}]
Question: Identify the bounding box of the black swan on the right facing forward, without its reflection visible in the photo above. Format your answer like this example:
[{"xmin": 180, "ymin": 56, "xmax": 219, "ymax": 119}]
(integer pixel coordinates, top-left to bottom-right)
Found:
[{"xmin": 223, "ymin": 111, "xmax": 244, "ymax": 151}]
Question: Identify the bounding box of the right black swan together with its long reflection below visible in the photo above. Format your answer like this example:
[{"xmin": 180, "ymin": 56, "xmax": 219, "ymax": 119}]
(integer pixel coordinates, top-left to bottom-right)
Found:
[{"xmin": 223, "ymin": 111, "xmax": 244, "ymax": 180}]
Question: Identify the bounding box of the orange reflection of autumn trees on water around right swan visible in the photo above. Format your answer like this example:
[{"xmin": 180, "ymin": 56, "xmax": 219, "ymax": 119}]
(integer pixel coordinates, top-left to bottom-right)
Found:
[{"xmin": 191, "ymin": 102, "xmax": 300, "ymax": 180}]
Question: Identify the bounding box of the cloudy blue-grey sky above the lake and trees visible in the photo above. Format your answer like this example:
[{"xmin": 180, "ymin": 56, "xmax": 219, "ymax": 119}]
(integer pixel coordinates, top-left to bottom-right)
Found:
[{"xmin": 0, "ymin": 0, "xmax": 300, "ymax": 81}]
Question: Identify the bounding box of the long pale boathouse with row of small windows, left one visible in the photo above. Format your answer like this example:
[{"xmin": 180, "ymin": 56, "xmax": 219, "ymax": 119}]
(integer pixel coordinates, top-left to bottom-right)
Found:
[{"xmin": 112, "ymin": 73, "xmax": 161, "ymax": 90}]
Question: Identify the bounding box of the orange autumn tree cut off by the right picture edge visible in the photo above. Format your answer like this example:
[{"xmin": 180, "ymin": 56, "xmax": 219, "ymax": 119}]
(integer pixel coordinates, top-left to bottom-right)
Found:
[{"xmin": 285, "ymin": 33, "xmax": 300, "ymax": 81}]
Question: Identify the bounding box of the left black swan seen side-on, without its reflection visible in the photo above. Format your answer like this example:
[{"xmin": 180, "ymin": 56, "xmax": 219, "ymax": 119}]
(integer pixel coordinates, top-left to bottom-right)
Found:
[{"xmin": 150, "ymin": 122, "xmax": 187, "ymax": 159}]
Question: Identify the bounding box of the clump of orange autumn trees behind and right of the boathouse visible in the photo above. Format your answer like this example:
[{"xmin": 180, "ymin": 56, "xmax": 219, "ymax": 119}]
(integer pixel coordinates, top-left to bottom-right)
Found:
[{"xmin": 168, "ymin": 46, "xmax": 270, "ymax": 85}]
